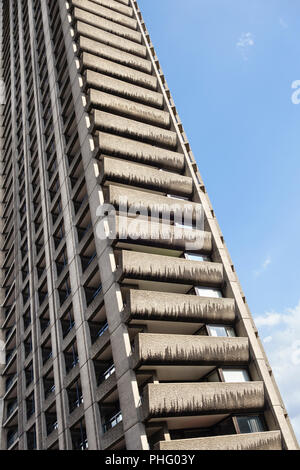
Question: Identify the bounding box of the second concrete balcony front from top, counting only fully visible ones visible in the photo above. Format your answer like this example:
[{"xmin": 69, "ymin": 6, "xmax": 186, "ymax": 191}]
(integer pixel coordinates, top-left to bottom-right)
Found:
[{"xmin": 75, "ymin": 21, "xmax": 147, "ymax": 57}]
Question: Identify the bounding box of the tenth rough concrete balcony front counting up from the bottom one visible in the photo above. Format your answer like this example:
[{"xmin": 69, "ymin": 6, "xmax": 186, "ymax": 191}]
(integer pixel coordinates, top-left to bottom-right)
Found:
[{"xmin": 92, "ymin": 110, "xmax": 177, "ymax": 150}]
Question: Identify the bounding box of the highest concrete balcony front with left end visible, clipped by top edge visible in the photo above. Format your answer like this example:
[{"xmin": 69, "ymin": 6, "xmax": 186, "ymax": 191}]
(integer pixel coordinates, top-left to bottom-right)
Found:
[{"xmin": 72, "ymin": 0, "xmax": 137, "ymax": 30}]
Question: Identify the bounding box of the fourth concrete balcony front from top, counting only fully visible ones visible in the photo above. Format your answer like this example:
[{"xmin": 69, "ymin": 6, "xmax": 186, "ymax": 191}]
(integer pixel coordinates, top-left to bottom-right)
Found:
[{"xmin": 81, "ymin": 51, "xmax": 157, "ymax": 90}]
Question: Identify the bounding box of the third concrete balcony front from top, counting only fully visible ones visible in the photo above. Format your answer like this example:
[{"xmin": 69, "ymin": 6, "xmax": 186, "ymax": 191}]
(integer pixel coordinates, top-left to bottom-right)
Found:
[{"xmin": 78, "ymin": 36, "xmax": 152, "ymax": 73}]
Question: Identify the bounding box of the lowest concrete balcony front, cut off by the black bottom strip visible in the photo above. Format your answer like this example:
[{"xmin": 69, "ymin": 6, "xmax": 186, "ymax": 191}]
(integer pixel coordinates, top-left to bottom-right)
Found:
[{"xmin": 155, "ymin": 431, "xmax": 282, "ymax": 451}]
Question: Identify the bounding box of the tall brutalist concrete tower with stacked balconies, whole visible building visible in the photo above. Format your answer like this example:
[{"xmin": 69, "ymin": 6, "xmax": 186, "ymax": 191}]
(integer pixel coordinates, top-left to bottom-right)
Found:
[{"xmin": 0, "ymin": 0, "xmax": 298, "ymax": 450}]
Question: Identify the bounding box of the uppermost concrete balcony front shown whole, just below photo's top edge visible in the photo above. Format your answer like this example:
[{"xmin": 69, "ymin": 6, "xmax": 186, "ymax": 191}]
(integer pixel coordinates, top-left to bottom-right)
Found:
[{"xmin": 73, "ymin": 8, "xmax": 142, "ymax": 43}]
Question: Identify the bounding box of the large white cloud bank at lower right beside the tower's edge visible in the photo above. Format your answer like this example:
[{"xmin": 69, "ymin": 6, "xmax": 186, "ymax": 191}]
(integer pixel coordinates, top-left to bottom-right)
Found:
[{"xmin": 255, "ymin": 302, "xmax": 300, "ymax": 439}]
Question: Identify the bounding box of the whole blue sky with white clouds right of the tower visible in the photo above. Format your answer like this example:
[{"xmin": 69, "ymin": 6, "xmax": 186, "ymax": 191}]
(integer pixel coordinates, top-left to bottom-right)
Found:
[{"xmin": 139, "ymin": 0, "xmax": 300, "ymax": 440}]
